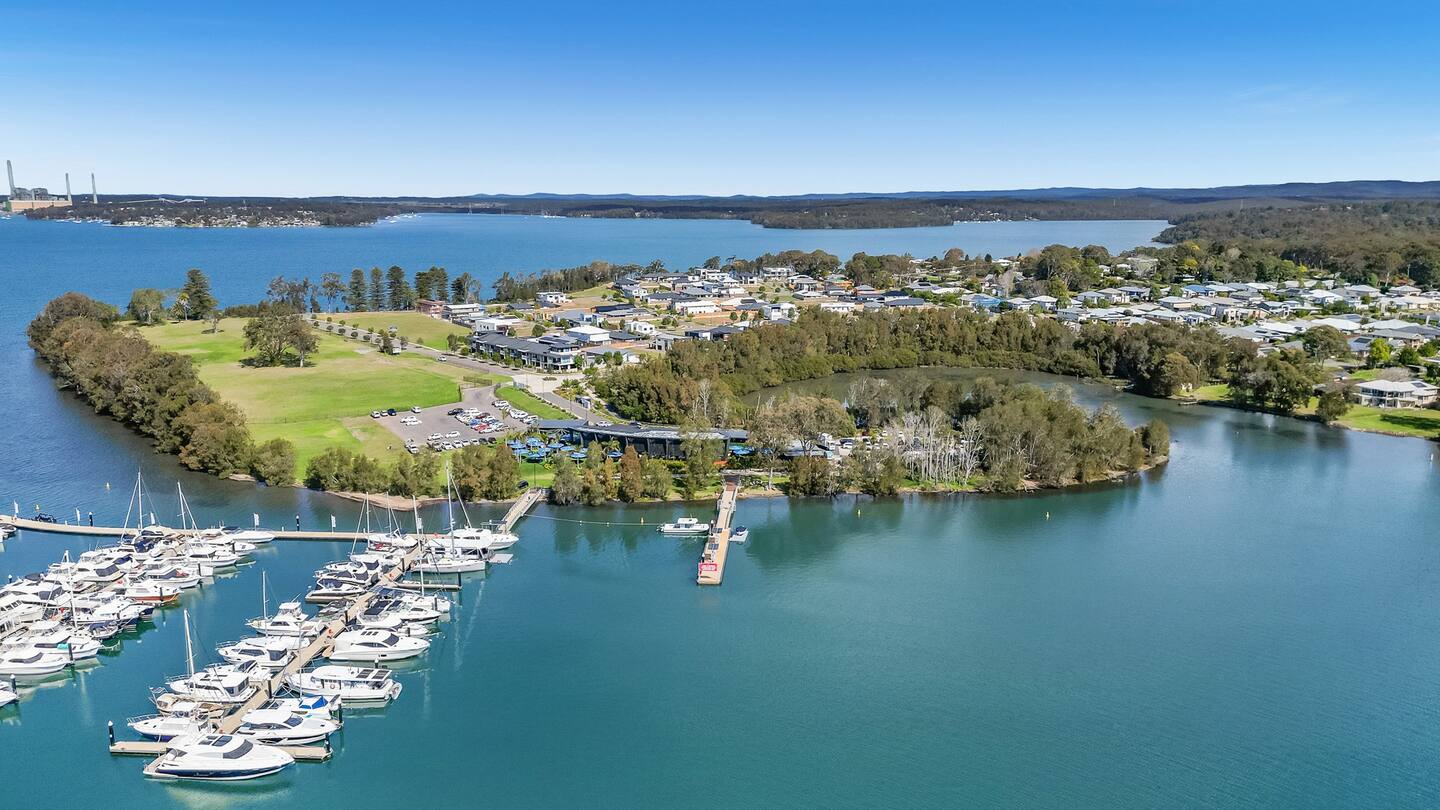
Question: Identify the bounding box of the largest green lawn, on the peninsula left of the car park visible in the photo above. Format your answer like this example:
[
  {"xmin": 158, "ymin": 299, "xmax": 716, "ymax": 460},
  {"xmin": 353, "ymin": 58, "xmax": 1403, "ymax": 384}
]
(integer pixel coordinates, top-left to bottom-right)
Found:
[{"xmin": 141, "ymin": 319, "xmax": 500, "ymax": 473}]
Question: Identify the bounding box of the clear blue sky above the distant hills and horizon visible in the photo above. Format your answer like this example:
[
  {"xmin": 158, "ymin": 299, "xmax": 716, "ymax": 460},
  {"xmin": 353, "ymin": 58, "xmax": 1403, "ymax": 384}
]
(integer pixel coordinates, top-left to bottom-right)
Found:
[{"xmin": 0, "ymin": 0, "xmax": 1440, "ymax": 196}]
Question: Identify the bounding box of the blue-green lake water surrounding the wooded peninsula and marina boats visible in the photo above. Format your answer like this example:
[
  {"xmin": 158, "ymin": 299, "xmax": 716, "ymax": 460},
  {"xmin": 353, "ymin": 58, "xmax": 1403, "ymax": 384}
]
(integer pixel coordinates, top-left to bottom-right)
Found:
[{"xmin": 0, "ymin": 218, "xmax": 1440, "ymax": 807}]
